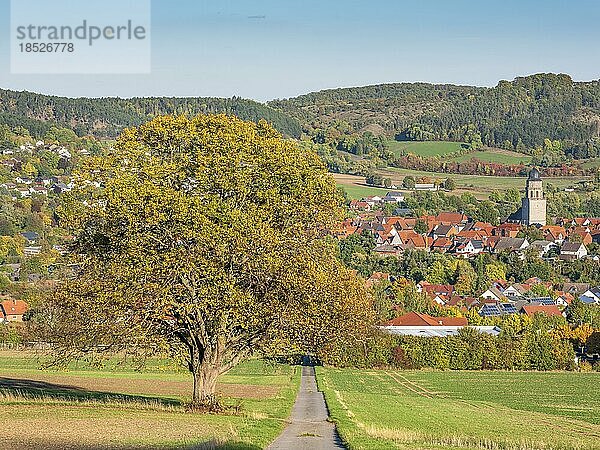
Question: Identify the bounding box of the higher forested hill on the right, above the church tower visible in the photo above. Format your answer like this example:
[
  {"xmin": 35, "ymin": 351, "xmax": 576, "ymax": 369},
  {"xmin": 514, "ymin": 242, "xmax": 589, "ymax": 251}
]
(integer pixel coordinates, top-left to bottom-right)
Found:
[{"xmin": 269, "ymin": 74, "xmax": 600, "ymax": 152}]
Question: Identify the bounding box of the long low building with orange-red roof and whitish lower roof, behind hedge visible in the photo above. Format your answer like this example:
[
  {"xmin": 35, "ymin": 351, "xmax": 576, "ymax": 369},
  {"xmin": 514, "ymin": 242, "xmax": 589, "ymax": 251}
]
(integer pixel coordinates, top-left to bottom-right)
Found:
[{"xmin": 379, "ymin": 312, "xmax": 501, "ymax": 337}]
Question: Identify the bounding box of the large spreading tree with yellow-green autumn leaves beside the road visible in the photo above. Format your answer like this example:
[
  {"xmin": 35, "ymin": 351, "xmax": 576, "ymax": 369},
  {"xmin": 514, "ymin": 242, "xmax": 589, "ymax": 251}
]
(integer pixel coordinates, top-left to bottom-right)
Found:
[{"xmin": 51, "ymin": 115, "xmax": 370, "ymax": 402}]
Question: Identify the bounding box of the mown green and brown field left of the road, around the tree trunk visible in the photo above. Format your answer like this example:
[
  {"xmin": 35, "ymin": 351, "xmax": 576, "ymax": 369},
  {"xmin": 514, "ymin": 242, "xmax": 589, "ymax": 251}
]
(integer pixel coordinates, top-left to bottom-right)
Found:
[{"xmin": 0, "ymin": 352, "xmax": 299, "ymax": 449}]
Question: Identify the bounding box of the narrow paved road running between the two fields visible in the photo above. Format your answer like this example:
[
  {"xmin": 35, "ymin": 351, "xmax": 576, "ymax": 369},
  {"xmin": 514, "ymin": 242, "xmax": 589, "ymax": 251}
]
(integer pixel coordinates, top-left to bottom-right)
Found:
[{"xmin": 268, "ymin": 365, "xmax": 346, "ymax": 450}]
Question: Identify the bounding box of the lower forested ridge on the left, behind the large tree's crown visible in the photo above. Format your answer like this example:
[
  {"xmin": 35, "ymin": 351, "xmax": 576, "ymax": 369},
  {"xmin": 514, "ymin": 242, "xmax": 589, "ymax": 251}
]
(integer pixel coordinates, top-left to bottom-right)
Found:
[{"xmin": 0, "ymin": 89, "xmax": 301, "ymax": 138}]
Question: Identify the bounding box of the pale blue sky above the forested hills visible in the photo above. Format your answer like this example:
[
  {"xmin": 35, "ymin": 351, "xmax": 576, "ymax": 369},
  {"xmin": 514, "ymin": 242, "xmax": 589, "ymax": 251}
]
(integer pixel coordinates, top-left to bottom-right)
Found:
[{"xmin": 0, "ymin": 0, "xmax": 600, "ymax": 101}]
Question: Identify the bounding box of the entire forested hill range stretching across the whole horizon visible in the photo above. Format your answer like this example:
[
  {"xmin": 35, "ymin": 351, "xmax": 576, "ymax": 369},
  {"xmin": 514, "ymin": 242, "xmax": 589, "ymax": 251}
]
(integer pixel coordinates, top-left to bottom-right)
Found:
[{"xmin": 0, "ymin": 74, "xmax": 600, "ymax": 153}]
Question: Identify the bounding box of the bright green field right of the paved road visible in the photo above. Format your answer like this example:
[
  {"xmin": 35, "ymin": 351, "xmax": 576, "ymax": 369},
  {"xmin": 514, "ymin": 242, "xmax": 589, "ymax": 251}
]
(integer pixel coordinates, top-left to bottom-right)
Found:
[{"xmin": 317, "ymin": 368, "xmax": 600, "ymax": 450}]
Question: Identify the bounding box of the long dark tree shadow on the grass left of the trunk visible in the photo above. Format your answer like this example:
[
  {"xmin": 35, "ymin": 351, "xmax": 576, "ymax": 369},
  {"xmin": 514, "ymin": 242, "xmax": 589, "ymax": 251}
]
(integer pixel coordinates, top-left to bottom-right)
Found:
[{"xmin": 0, "ymin": 377, "xmax": 182, "ymax": 406}]
